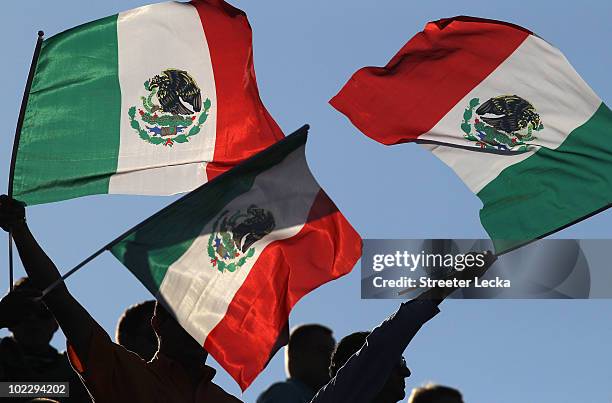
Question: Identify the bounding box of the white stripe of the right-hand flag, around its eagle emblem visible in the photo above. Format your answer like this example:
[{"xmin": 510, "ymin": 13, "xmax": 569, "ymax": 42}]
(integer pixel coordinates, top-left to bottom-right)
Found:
[{"xmin": 419, "ymin": 35, "xmax": 601, "ymax": 193}]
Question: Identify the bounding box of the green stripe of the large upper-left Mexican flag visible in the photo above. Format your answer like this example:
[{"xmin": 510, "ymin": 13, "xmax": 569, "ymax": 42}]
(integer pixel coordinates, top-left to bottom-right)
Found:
[{"xmin": 14, "ymin": 15, "xmax": 121, "ymax": 204}]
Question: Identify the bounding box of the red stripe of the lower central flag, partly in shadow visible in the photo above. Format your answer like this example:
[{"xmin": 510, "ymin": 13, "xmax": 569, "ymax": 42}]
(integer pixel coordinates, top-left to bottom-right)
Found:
[{"xmin": 204, "ymin": 191, "xmax": 361, "ymax": 390}]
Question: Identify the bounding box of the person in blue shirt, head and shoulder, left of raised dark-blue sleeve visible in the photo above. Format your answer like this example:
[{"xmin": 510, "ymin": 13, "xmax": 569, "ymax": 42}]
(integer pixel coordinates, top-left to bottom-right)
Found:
[{"xmin": 257, "ymin": 324, "xmax": 336, "ymax": 403}]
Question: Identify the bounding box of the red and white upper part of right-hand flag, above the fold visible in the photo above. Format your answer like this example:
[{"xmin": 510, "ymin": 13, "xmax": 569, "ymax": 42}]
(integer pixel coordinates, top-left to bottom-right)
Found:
[{"xmin": 330, "ymin": 17, "xmax": 601, "ymax": 153}]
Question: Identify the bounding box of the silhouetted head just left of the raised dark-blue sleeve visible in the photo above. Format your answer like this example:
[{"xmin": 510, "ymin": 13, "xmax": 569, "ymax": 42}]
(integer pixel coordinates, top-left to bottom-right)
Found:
[{"xmin": 285, "ymin": 324, "xmax": 336, "ymax": 392}]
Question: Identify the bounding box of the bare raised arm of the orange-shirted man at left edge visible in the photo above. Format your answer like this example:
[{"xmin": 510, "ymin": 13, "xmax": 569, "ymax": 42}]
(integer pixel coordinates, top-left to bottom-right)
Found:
[{"xmin": 0, "ymin": 195, "xmax": 99, "ymax": 357}]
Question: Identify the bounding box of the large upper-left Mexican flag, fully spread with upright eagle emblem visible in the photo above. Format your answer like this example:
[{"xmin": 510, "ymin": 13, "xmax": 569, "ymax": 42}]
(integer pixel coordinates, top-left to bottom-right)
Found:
[{"xmin": 13, "ymin": 0, "xmax": 283, "ymax": 204}]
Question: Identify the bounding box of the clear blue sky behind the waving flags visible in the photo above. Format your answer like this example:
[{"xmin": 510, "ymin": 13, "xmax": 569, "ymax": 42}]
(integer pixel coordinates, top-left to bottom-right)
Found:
[{"xmin": 0, "ymin": 0, "xmax": 612, "ymax": 403}]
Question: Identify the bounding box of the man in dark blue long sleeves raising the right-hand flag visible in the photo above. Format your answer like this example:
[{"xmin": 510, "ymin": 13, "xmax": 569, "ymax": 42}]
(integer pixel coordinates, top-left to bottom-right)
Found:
[{"xmin": 311, "ymin": 253, "xmax": 495, "ymax": 403}]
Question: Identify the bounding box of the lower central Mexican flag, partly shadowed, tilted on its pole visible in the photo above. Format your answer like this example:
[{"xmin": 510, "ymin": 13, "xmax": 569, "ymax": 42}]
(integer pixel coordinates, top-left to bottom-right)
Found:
[{"xmin": 110, "ymin": 130, "xmax": 361, "ymax": 390}]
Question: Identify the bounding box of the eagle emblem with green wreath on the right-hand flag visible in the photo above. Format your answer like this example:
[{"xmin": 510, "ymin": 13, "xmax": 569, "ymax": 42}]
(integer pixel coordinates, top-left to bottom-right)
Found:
[{"xmin": 461, "ymin": 95, "xmax": 544, "ymax": 152}]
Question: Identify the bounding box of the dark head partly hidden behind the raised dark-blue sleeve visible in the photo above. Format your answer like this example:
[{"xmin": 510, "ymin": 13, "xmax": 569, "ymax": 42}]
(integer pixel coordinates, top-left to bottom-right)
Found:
[{"xmin": 329, "ymin": 332, "xmax": 410, "ymax": 403}]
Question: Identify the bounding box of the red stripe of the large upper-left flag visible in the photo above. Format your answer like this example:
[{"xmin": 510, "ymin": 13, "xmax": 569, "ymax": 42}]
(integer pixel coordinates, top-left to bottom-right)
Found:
[{"xmin": 191, "ymin": 0, "xmax": 284, "ymax": 181}]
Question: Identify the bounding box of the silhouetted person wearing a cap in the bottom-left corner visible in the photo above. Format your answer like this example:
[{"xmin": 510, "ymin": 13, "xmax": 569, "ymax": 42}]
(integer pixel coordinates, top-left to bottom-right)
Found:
[{"xmin": 0, "ymin": 277, "xmax": 90, "ymax": 403}]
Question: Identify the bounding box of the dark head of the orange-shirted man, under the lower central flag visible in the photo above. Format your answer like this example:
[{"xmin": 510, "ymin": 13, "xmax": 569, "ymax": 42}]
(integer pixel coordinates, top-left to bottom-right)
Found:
[{"xmin": 151, "ymin": 302, "xmax": 208, "ymax": 367}]
